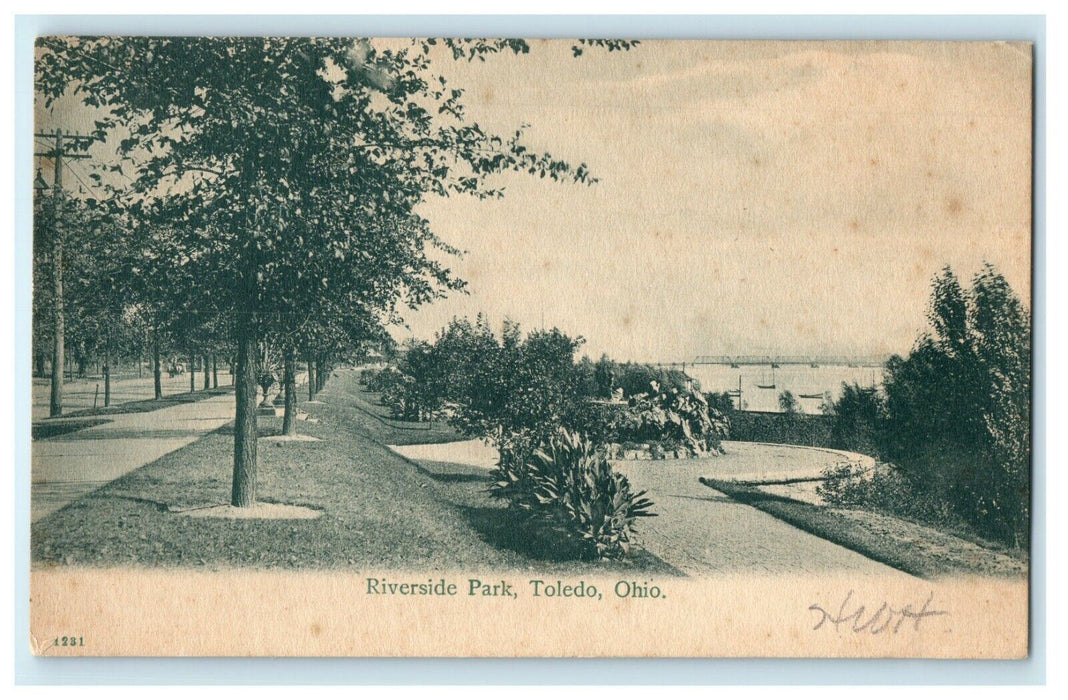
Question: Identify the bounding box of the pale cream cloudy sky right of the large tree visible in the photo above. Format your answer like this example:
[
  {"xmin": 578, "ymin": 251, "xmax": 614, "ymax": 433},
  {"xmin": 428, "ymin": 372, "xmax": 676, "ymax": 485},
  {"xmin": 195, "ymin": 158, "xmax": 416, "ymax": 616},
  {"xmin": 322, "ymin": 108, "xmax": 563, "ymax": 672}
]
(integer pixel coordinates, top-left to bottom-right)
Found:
[{"xmin": 397, "ymin": 42, "xmax": 1031, "ymax": 361}]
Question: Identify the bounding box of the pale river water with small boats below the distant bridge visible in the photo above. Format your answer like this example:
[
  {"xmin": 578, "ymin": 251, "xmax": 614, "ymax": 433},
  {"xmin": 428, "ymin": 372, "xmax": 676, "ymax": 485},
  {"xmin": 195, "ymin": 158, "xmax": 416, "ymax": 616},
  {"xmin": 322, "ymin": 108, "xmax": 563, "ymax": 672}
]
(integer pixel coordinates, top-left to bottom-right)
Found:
[{"xmin": 686, "ymin": 364, "xmax": 882, "ymax": 414}]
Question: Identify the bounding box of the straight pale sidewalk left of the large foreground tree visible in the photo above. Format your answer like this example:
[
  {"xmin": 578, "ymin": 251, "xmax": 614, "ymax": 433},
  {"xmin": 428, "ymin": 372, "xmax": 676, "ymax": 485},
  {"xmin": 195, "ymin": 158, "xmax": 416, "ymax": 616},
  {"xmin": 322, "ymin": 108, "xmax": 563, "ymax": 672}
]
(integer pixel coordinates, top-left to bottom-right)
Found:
[{"xmin": 30, "ymin": 393, "xmax": 235, "ymax": 522}]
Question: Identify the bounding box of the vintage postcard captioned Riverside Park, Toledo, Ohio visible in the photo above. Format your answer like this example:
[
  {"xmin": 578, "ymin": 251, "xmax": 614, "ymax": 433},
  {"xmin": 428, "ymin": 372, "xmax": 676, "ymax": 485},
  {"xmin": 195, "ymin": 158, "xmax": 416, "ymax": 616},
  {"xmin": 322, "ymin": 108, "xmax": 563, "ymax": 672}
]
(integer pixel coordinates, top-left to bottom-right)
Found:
[{"xmin": 27, "ymin": 36, "xmax": 1033, "ymax": 658}]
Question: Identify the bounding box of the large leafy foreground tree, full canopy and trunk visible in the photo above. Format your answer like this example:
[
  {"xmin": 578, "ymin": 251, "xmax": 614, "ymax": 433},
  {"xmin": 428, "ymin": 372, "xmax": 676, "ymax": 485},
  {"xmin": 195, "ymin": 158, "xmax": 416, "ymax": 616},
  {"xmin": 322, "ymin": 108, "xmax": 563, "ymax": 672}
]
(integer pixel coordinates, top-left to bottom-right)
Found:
[{"xmin": 36, "ymin": 37, "xmax": 629, "ymax": 507}]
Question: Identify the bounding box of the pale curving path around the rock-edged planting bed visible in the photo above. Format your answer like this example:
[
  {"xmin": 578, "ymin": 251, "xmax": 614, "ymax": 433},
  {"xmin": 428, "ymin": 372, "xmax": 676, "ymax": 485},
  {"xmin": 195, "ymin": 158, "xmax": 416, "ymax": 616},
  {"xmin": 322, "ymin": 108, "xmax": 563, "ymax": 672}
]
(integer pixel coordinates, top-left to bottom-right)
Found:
[{"xmin": 391, "ymin": 440, "xmax": 905, "ymax": 576}]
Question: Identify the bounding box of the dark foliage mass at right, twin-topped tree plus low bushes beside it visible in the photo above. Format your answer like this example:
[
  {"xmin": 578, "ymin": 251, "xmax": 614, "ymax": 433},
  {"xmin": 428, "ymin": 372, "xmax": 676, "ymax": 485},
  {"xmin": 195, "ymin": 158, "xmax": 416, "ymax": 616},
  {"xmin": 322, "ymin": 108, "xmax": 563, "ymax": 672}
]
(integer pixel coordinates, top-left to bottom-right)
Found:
[{"xmin": 807, "ymin": 264, "xmax": 1031, "ymax": 547}]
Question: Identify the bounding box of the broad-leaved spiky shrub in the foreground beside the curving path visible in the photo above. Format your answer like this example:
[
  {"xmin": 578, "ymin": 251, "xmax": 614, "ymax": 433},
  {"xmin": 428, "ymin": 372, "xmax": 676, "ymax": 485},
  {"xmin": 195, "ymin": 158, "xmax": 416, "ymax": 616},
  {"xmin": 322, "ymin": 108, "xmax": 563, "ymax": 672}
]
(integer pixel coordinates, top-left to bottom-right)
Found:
[{"xmin": 491, "ymin": 429, "xmax": 654, "ymax": 559}]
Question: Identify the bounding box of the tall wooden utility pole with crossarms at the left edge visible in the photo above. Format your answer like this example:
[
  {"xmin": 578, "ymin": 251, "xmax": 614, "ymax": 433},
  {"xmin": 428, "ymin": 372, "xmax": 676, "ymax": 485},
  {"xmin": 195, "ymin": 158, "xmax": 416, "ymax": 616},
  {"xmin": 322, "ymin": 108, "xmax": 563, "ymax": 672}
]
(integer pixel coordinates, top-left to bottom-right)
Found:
[{"xmin": 34, "ymin": 129, "xmax": 93, "ymax": 418}]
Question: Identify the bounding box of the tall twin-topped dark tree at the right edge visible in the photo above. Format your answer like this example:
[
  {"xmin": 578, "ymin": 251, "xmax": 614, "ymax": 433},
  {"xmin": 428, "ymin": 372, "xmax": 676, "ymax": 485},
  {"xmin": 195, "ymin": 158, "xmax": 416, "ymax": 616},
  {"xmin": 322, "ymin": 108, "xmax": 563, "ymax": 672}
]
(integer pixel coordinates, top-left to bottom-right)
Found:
[{"xmin": 880, "ymin": 264, "xmax": 1031, "ymax": 544}]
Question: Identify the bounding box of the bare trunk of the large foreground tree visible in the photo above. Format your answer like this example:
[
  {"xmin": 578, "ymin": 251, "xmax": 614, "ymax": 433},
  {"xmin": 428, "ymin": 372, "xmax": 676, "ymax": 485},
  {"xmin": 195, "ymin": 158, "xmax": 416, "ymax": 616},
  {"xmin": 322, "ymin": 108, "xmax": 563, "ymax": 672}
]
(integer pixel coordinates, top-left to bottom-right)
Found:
[{"xmin": 230, "ymin": 314, "xmax": 257, "ymax": 508}]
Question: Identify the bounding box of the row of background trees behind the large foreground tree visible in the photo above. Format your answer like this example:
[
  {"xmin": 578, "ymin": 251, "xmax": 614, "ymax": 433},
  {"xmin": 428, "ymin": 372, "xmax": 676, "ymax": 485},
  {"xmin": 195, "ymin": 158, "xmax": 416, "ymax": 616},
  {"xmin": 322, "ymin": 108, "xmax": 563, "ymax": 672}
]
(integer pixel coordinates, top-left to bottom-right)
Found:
[{"xmin": 33, "ymin": 185, "xmax": 363, "ymax": 408}]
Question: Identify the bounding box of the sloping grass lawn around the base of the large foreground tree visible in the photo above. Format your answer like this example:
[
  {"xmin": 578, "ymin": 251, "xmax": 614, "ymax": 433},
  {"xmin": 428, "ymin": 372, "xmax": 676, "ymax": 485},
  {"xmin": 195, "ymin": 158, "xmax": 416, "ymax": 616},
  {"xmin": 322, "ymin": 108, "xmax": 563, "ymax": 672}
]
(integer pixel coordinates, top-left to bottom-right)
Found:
[{"xmin": 31, "ymin": 372, "xmax": 673, "ymax": 574}]
